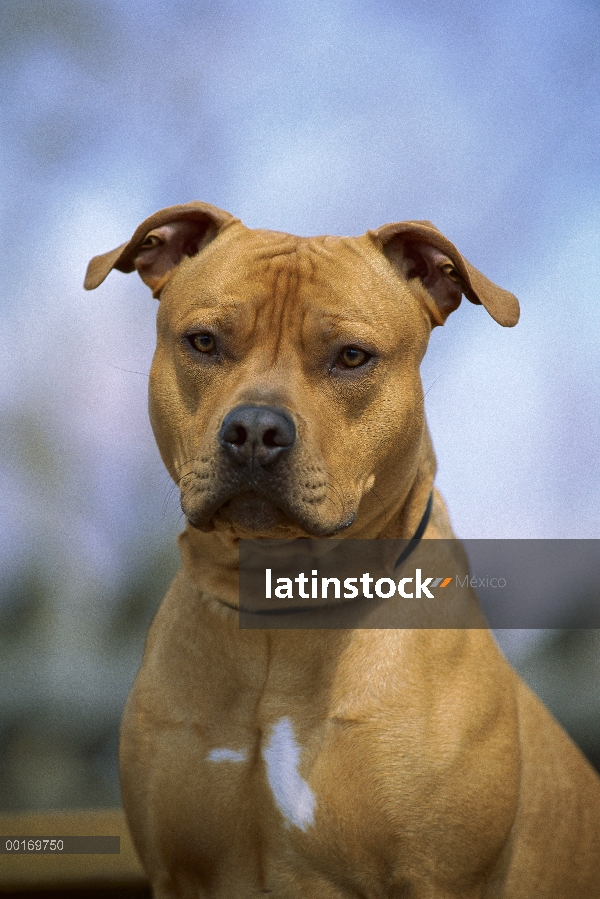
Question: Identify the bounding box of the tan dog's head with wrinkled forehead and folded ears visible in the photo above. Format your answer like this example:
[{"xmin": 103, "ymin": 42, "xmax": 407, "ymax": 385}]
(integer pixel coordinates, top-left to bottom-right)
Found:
[{"xmin": 85, "ymin": 203, "xmax": 519, "ymax": 537}]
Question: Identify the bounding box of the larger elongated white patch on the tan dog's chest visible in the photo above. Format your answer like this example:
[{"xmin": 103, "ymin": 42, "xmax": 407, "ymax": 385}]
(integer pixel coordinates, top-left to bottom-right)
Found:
[{"xmin": 262, "ymin": 718, "xmax": 315, "ymax": 830}]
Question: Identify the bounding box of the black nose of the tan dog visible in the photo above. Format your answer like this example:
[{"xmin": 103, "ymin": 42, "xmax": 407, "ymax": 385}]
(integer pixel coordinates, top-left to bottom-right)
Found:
[{"xmin": 219, "ymin": 406, "xmax": 296, "ymax": 467}]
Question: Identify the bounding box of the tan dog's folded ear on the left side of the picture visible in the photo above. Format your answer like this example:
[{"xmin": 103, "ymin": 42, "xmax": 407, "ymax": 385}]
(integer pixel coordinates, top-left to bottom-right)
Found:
[{"xmin": 83, "ymin": 202, "xmax": 238, "ymax": 298}]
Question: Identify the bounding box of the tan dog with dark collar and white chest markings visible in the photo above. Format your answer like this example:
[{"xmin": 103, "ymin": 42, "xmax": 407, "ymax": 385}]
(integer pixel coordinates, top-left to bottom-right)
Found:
[{"xmin": 86, "ymin": 203, "xmax": 600, "ymax": 899}]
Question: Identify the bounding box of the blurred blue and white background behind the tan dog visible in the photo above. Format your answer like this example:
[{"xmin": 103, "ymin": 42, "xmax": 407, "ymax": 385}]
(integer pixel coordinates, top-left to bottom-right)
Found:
[{"xmin": 0, "ymin": 0, "xmax": 600, "ymax": 809}]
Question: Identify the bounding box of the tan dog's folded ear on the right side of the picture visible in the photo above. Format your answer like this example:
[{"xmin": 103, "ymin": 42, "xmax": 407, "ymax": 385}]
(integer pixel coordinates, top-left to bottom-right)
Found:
[{"xmin": 368, "ymin": 221, "xmax": 519, "ymax": 328}]
